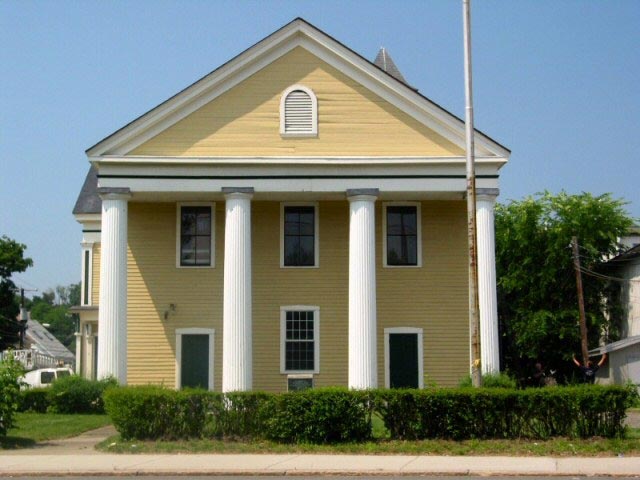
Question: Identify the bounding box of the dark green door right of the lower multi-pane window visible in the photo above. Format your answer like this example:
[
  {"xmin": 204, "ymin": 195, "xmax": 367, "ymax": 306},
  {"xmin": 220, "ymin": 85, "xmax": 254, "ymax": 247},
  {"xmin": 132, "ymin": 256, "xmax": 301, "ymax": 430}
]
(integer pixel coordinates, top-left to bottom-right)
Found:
[{"xmin": 389, "ymin": 333, "xmax": 419, "ymax": 388}]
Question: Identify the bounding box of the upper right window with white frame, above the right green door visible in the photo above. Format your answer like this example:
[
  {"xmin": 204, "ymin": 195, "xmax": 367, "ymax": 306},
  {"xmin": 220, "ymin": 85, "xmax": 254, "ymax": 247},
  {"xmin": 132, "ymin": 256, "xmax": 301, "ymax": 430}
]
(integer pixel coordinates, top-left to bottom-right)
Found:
[{"xmin": 383, "ymin": 202, "xmax": 422, "ymax": 267}]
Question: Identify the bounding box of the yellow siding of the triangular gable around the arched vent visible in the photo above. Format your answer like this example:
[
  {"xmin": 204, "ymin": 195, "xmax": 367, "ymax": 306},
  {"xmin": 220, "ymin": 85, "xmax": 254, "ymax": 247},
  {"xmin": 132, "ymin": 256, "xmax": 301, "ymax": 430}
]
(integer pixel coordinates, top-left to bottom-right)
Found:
[{"xmin": 131, "ymin": 47, "xmax": 463, "ymax": 156}]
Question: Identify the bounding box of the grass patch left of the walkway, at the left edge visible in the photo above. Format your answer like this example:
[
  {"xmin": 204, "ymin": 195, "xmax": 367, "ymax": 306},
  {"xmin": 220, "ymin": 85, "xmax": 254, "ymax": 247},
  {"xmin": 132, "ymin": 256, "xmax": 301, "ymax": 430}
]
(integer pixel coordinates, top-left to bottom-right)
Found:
[{"xmin": 0, "ymin": 413, "xmax": 111, "ymax": 448}]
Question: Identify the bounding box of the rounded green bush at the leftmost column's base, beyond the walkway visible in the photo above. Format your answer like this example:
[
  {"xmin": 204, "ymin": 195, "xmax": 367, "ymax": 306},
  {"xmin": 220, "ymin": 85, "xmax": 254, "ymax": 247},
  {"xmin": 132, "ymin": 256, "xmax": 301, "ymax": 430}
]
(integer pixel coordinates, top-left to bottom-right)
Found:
[{"xmin": 48, "ymin": 375, "xmax": 117, "ymax": 413}]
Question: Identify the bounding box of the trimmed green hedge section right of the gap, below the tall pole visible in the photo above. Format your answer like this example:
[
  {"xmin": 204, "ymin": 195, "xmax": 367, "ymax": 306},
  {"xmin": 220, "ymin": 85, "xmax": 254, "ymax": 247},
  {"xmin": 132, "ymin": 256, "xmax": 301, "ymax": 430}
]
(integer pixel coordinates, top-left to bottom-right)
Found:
[{"xmin": 375, "ymin": 385, "xmax": 630, "ymax": 440}]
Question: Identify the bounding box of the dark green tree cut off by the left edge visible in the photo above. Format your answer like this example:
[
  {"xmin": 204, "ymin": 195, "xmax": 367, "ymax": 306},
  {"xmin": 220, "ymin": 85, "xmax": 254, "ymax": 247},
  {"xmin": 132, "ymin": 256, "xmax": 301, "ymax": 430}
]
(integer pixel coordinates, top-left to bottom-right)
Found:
[{"xmin": 0, "ymin": 235, "xmax": 33, "ymax": 351}]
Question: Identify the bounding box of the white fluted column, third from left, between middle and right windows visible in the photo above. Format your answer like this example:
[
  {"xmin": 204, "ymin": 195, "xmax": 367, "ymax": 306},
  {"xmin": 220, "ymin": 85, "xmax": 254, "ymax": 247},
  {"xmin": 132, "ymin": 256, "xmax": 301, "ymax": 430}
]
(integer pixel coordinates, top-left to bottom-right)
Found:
[{"xmin": 347, "ymin": 189, "xmax": 378, "ymax": 389}]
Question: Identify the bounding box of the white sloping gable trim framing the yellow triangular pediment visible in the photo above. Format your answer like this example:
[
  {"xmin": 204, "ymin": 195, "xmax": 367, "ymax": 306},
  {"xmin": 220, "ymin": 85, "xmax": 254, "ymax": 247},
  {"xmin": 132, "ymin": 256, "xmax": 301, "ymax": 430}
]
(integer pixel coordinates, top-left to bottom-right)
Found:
[{"xmin": 86, "ymin": 18, "xmax": 510, "ymax": 159}]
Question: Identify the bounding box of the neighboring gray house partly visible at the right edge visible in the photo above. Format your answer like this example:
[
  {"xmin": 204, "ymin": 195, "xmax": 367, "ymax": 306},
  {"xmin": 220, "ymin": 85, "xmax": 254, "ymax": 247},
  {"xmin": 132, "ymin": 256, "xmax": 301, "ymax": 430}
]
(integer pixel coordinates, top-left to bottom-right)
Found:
[{"xmin": 590, "ymin": 242, "xmax": 640, "ymax": 388}]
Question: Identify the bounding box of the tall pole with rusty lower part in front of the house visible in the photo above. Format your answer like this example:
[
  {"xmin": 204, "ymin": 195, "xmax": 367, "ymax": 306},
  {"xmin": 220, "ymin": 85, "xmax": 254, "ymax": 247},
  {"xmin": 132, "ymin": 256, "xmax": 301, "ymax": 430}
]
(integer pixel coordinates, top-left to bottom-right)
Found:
[{"xmin": 462, "ymin": 0, "xmax": 482, "ymax": 387}]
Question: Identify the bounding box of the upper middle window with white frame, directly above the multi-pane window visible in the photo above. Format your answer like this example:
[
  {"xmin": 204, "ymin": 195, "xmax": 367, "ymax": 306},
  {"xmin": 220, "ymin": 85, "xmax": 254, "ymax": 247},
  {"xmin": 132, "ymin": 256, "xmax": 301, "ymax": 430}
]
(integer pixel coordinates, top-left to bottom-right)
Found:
[{"xmin": 280, "ymin": 203, "xmax": 319, "ymax": 267}]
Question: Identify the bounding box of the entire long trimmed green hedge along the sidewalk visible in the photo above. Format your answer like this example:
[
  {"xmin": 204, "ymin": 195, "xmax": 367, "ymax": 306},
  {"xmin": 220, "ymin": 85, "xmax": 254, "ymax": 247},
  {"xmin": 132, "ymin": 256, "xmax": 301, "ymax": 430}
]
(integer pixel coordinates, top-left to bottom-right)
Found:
[{"xmin": 104, "ymin": 385, "xmax": 633, "ymax": 443}]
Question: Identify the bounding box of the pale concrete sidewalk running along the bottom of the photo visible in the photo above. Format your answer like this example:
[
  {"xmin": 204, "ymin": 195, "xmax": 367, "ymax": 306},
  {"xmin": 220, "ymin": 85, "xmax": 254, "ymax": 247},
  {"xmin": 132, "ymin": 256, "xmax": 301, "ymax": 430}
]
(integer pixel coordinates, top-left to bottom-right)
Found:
[{"xmin": 0, "ymin": 453, "xmax": 640, "ymax": 476}]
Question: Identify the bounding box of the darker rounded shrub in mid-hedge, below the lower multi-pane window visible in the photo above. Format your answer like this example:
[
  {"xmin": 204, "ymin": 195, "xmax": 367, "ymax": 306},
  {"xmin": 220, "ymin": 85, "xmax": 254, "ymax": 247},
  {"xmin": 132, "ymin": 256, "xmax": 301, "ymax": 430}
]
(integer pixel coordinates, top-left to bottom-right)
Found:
[{"xmin": 265, "ymin": 388, "xmax": 373, "ymax": 443}]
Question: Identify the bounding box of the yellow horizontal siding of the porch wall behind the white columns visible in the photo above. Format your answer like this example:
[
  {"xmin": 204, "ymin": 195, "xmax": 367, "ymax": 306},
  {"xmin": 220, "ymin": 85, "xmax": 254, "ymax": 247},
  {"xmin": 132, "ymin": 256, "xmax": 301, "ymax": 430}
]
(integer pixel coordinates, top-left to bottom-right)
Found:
[{"xmin": 128, "ymin": 201, "xmax": 469, "ymax": 391}]
